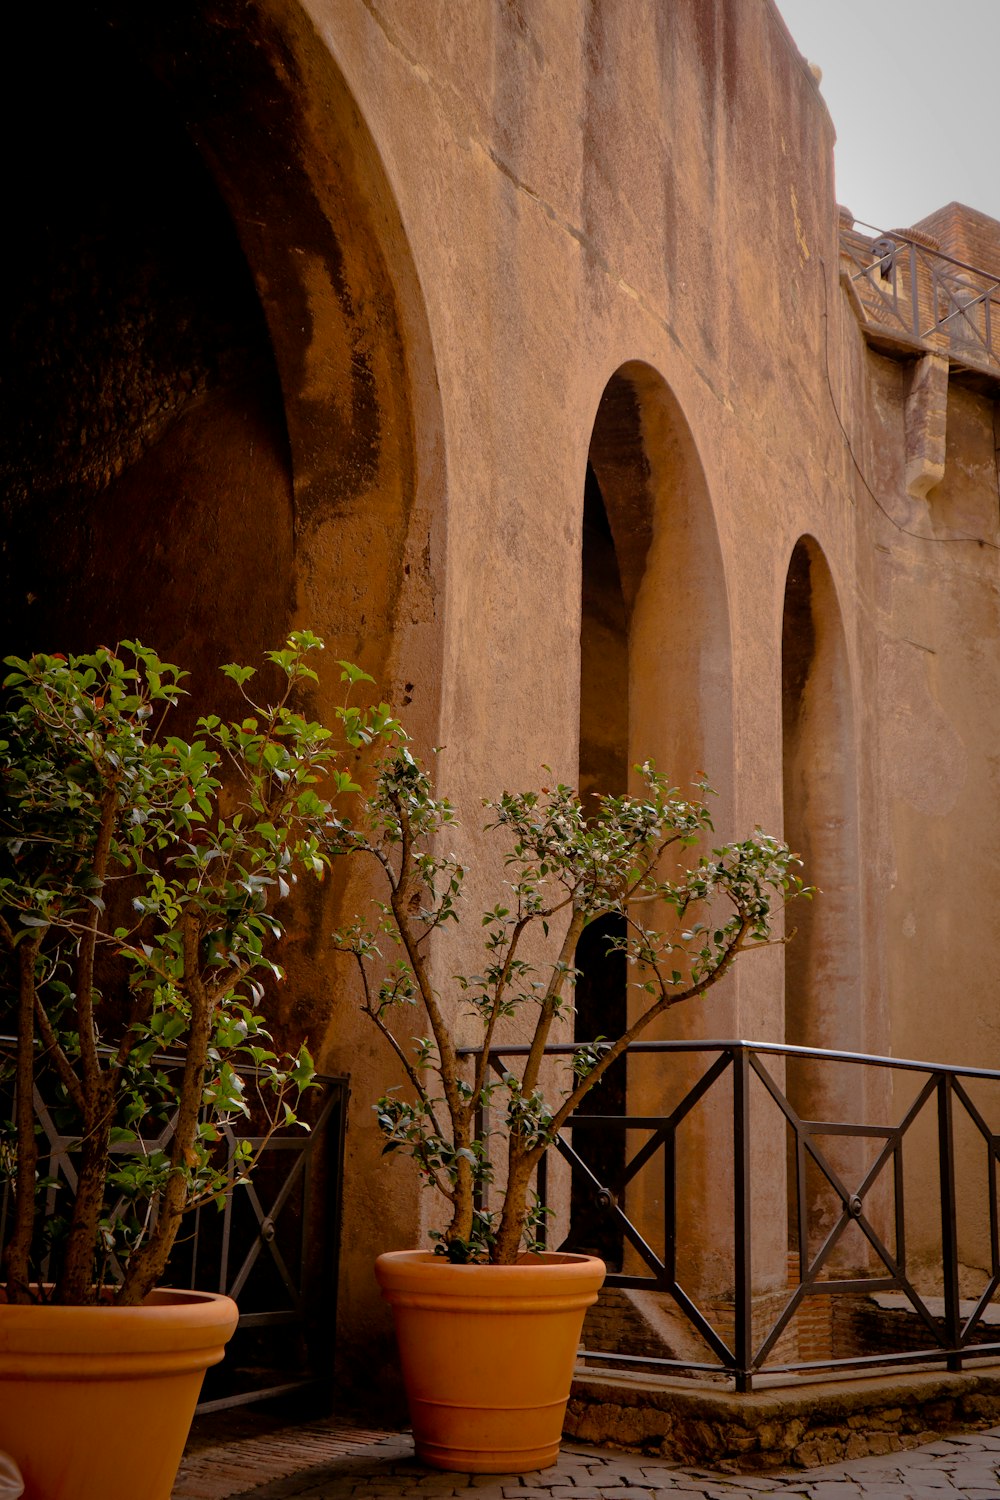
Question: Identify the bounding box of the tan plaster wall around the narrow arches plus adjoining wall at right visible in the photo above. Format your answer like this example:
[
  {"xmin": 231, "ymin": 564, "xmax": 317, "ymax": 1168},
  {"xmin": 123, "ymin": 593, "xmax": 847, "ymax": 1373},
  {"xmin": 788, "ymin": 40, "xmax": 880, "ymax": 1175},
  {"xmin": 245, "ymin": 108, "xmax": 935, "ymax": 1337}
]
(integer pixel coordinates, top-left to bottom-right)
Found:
[{"xmin": 262, "ymin": 0, "xmax": 996, "ymax": 1350}]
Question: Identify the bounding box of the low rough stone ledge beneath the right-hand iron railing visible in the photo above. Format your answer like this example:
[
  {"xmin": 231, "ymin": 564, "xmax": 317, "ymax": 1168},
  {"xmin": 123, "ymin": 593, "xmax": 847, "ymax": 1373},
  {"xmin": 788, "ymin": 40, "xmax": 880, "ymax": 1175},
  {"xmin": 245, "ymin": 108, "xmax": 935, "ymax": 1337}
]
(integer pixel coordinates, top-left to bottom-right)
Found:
[{"xmin": 565, "ymin": 1364, "xmax": 1000, "ymax": 1472}]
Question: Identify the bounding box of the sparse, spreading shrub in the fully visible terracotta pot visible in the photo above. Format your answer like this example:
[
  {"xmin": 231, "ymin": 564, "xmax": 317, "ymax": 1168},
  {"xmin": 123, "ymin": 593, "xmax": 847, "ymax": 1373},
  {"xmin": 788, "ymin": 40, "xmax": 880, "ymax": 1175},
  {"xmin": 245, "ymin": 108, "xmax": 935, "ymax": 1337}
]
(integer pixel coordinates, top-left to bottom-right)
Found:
[{"xmin": 331, "ymin": 744, "xmax": 802, "ymax": 1472}]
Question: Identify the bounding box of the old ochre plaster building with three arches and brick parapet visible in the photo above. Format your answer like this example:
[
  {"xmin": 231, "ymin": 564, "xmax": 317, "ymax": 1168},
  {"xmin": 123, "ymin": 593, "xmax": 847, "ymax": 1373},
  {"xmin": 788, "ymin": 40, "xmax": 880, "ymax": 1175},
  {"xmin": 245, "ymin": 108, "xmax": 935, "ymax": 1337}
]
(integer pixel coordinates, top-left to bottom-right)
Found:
[{"xmin": 0, "ymin": 0, "xmax": 1000, "ymax": 1392}]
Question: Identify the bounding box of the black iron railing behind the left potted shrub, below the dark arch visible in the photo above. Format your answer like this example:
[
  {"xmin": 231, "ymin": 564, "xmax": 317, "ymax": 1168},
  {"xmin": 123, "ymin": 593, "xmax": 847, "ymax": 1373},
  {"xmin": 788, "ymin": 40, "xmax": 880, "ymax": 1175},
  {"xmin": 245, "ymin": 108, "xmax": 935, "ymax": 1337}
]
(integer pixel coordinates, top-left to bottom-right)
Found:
[{"xmin": 0, "ymin": 1037, "xmax": 348, "ymax": 1412}]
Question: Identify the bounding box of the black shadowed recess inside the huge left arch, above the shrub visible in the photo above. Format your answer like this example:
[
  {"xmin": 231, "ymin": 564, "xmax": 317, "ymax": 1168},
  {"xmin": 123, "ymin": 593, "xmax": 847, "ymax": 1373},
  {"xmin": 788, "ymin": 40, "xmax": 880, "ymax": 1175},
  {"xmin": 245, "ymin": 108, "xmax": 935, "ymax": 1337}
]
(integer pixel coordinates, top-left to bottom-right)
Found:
[{"xmin": 0, "ymin": 8, "xmax": 292, "ymax": 681}]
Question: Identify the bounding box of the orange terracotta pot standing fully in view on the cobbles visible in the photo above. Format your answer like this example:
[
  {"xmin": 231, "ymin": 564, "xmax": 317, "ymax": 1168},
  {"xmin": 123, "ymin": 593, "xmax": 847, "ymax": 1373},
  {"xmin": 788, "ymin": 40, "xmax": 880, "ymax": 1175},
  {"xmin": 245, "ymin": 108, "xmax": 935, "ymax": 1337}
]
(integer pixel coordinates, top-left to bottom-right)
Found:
[{"xmin": 375, "ymin": 1250, "xmax": 604, "ymax": 1475}]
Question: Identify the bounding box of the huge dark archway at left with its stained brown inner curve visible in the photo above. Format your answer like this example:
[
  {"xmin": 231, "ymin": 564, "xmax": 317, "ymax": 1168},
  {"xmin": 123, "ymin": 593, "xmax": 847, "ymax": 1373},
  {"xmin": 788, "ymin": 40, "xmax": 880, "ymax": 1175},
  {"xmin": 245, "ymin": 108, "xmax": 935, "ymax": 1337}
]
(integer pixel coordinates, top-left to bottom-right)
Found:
[{"xmin": 0, "ymin": 0, "xmax": 442, "ymax": 1368}]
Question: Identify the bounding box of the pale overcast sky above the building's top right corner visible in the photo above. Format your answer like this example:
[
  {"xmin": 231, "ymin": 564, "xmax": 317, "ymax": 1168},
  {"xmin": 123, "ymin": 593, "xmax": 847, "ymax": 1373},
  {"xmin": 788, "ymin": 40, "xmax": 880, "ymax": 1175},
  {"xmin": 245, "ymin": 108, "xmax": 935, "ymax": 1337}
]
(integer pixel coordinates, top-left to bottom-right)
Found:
[{"xmin": 777, "ymin": 0, "xmax": 1000, "ymax": 230}]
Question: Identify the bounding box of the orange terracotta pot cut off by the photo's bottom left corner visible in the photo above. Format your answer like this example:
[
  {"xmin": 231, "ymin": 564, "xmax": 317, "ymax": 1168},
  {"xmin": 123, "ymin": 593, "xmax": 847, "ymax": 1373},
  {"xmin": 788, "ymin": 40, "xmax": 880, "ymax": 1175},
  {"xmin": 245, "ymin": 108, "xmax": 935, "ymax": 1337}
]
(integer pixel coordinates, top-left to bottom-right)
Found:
[{"xmin": 0, "ymin": 1290, "xmax": 238, "ymax": 1500}]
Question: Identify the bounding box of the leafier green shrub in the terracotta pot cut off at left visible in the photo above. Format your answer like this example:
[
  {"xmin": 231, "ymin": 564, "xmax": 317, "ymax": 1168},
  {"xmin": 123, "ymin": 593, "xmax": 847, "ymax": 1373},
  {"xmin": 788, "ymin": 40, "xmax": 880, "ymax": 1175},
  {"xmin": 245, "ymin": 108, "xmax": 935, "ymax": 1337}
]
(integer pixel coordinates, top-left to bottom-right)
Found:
[{"xmin": 0, "ymin": 632, "xmax": 389, "ymax": 1500}]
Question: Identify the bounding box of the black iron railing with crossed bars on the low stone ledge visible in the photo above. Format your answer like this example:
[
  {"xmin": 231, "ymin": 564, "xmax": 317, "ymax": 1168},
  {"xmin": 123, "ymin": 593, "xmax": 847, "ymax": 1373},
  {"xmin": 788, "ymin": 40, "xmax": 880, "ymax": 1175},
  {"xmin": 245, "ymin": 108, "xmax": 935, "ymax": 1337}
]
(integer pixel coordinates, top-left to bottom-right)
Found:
[{"xmin": 464, "ymin": 1041, "xmax": 1000, "ymax": 1391}]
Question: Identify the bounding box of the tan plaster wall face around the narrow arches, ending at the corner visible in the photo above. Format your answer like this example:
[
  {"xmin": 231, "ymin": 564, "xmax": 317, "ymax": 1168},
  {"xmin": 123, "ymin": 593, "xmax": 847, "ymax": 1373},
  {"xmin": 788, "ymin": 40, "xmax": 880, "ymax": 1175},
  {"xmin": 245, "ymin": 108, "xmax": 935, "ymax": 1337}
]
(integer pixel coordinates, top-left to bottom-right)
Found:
[{"xmin": 310, "ymin": 0, "xmax": 871, "ymax": 1338}]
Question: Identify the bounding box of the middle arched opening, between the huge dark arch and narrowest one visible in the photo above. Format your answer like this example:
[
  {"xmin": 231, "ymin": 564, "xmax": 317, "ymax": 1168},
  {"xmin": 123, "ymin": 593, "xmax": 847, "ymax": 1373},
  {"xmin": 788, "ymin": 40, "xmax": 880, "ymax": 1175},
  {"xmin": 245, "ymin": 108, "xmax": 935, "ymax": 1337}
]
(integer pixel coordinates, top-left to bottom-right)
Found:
[{"xmin": 573, "ymin": 362, "xmax": 735, "ymax": 1293}]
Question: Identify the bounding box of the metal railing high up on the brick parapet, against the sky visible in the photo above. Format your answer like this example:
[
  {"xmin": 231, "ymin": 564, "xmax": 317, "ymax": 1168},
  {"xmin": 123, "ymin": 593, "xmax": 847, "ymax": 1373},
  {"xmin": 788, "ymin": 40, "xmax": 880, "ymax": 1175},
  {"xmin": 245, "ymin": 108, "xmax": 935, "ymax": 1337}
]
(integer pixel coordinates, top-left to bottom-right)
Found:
[{"xmin": 840, "ymin": 230, "xmax": 1000, "ymax": 377}]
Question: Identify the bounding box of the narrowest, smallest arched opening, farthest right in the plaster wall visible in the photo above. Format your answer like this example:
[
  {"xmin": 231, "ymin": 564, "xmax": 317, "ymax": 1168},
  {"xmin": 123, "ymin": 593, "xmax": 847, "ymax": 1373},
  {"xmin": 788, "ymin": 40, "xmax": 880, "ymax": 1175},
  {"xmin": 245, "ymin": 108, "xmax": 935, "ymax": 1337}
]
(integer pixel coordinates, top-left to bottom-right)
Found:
[{"xmin": 781, "ymin": 537, "xmax": 867, "ymax": 1266}]
